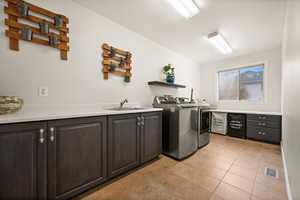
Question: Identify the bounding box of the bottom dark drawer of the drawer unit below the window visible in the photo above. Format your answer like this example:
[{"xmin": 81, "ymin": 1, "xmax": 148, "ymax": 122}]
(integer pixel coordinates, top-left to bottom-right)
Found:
[{"xmin": 247, "ymin": 127, "xmax": 281, "ymax": 144}]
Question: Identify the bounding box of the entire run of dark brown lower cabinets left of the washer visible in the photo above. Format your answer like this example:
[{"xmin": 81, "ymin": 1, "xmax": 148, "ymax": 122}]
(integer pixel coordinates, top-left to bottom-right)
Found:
[{"xmin": 0, "ymin": 112, "xmax": 162, "ymax": 200}]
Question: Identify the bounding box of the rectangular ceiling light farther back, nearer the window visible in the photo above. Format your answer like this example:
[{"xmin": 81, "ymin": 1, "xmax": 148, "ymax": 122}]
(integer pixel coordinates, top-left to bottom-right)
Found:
[{"xmin": 208, "ymin": 32, "xmax": 233, "ymax": 54}]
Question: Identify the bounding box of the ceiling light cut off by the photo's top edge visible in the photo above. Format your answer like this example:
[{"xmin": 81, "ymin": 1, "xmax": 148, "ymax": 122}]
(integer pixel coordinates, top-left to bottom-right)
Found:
[{"xmin": 167, "ymin": 0, "xmax": 199, "ymax": 19}]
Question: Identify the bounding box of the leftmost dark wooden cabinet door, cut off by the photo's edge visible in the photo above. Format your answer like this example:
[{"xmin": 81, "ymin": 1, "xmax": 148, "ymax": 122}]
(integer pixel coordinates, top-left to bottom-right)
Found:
[{"xmin": 0, "ymin": 123, "xmax": 47, "ymax": 200}]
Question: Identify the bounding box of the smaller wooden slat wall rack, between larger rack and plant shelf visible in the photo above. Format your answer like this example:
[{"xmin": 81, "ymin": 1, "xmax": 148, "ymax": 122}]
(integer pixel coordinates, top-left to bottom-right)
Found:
[{"xmin": 102, "ymin": 44, "xmax": 132, "ymax": 82}]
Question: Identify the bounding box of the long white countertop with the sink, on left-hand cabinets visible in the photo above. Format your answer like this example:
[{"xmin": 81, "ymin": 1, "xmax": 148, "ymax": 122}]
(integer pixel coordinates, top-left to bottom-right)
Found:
[{"xmin": 0, "ymin": 106, "xmax": 162, "ymax": 124}]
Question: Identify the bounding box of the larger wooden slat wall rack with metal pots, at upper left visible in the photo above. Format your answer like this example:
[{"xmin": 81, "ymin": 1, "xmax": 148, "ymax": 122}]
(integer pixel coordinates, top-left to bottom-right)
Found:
[{"xmin": 4, "ymin": 0, "xmax": 70, "ymax": 60}]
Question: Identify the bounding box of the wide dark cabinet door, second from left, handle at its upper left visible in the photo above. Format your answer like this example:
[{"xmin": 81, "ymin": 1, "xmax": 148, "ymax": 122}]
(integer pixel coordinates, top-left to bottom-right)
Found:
[{"xmin": 48, "ymin": 117, "xmax": 107, "ymax": 199}]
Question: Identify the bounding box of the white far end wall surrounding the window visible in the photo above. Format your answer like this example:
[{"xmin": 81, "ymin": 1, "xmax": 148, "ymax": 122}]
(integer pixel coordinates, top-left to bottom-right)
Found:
[{"xmin": 200, "ymin": 47, "xmax": 281, "ymax": 112}]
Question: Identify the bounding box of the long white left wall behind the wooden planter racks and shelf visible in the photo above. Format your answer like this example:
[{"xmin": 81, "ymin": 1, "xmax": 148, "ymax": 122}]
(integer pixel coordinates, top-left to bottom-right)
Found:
[{"xmin": 0, "ymin": 0, "xmax": 200, "ymax": 106}]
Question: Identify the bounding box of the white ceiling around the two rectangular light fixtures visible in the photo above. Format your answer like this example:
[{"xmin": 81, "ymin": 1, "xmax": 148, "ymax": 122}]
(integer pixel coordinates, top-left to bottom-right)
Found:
[{"xmin": 74, "ymin": 0, "xmax": 286, "ymax": 63}]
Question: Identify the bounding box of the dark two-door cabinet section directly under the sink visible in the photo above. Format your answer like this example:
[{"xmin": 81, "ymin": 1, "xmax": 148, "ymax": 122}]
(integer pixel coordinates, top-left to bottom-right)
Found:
[{"xmin": 108, "ymin": 112, "xmax": 162, "ymax": 177}]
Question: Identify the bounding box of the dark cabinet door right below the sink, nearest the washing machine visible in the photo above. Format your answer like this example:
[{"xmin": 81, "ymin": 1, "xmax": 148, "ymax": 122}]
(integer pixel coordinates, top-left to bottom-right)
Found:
[{"xmin": 141, "ymin": 112, "xmax": 162, "ymax": 163}]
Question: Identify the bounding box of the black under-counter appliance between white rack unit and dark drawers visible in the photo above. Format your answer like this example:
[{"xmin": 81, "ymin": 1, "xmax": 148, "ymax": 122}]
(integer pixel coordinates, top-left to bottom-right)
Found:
[{"xmin": 227, "ymin": 113, "xmax": 246, "ymax": 138}]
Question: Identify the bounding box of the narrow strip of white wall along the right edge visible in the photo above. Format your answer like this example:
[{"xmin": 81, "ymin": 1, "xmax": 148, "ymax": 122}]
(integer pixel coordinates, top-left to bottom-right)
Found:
[{"xmin": 282, "ymin": 0, "xmax": 300, "ymax": 200}]
